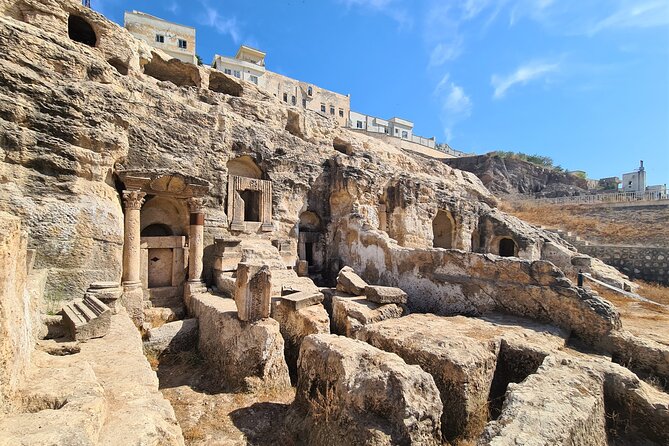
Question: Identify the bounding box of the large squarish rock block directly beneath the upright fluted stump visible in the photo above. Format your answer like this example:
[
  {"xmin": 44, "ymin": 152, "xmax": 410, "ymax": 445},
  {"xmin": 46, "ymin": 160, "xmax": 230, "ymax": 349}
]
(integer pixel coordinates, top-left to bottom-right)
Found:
[{"xmin": 191, "ymin": 293, "xmax": 290, "ymax": 390}]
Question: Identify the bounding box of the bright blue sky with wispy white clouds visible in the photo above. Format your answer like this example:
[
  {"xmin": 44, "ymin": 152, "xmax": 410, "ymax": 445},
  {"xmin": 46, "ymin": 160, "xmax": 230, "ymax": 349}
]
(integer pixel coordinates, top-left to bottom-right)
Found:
[{"xmin": 92, "ymin": 0, "xmax": 669, "ymax": 184}]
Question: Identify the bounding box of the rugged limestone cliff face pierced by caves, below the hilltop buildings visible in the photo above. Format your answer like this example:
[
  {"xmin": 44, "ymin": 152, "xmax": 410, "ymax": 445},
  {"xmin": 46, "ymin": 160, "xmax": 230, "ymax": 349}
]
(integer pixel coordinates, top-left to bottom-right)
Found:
[{"xmin": 0, "ymin": 0, "xmax": 628, "ymax": 299}]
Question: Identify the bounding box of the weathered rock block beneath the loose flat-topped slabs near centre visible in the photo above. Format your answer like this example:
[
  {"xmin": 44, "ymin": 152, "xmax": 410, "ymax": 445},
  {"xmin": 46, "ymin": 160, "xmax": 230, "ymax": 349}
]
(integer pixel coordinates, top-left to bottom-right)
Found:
[{"xmin": 332, "ymin": 293, "xmax": 404, "ymax": 337}]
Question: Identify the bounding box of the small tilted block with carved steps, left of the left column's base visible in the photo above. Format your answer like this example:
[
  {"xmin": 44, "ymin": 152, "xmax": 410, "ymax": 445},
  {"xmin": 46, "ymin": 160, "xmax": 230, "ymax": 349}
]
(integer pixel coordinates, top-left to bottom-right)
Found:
[{"xmin": 63, "ymin": 295, "xmax": 111, "ymax": 341}]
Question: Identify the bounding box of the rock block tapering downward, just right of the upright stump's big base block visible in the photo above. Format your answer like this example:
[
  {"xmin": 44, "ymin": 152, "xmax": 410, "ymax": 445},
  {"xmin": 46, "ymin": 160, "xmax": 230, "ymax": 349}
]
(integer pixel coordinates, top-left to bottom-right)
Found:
[{"xmin": 272, "ymin": 295, "xmax": 330, "ymax": 382}]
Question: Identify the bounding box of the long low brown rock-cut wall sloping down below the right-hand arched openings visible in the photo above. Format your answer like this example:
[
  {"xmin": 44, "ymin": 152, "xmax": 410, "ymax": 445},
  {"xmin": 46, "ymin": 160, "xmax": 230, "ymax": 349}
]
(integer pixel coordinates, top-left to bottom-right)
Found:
[{"xmin": 339, "ymin": 217, "xmax": 621, "ymax": 345}]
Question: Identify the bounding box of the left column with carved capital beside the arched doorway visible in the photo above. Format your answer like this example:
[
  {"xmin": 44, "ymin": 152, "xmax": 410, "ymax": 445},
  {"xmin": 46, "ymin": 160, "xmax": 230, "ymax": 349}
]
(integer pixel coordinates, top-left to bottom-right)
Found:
[{"xmin": 121, "ymin": 190, "xmax": 146, "ymax": 326}]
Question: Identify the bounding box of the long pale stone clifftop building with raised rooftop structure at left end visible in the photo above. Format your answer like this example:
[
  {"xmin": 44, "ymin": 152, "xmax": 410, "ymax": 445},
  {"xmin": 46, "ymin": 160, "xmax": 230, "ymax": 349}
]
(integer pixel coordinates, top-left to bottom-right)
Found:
[{"xmin": 212, "ymin": 45, "xmax": 351, "ymax": 127}]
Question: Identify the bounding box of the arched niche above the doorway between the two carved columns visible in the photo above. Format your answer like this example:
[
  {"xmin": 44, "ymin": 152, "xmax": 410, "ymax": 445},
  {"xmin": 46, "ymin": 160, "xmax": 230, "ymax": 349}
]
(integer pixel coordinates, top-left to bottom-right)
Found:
[{"xmin": 140, "ymin": 196, "xmax": 189, "ymax": 237}]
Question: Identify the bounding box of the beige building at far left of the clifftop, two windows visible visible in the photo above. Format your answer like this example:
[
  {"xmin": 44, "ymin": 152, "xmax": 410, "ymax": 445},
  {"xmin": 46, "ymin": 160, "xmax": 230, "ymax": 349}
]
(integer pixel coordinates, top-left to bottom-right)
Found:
[{"xmin": 123, "ymin": 11, "xmax": 197, "ymax": 64}]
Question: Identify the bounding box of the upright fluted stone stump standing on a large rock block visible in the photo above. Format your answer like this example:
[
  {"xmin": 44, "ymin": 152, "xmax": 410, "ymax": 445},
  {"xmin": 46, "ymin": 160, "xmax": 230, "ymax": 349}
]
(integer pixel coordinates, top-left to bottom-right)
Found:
[{"xmin": 235, "ymin": 263, "xmax": 272, "ymax": 322}]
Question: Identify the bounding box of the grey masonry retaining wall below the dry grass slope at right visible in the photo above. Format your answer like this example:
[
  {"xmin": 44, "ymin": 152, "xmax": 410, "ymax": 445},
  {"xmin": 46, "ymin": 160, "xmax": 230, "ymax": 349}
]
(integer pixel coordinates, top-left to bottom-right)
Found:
[{"xmin": 578, "ymin": 244, "xmax": 669, "ymax": 285}]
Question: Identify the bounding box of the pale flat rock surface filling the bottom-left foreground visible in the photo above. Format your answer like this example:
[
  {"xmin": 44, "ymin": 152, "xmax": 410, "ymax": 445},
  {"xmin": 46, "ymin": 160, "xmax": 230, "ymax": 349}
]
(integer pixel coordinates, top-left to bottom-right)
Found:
[{"xmin": 0, "ymin": 314, "xmax": 184, "ymax": 446}]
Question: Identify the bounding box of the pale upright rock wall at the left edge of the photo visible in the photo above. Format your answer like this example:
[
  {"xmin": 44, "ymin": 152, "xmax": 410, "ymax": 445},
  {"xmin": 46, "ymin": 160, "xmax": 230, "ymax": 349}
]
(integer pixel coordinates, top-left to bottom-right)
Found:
[{"xmin": 0, "ymin": 212, "xmax": 34, "ymax": 414}]
